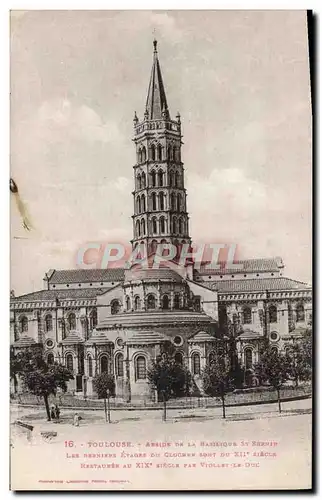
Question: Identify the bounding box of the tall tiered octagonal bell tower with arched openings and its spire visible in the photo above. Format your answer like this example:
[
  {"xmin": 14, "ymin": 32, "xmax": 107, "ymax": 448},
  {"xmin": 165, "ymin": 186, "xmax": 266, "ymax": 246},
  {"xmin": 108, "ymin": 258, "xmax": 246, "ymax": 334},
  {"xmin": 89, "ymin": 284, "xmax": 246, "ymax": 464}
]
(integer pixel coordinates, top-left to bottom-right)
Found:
[{"xmin": 132, "ymin": 40, "xmax": 191, "ymax": 253}]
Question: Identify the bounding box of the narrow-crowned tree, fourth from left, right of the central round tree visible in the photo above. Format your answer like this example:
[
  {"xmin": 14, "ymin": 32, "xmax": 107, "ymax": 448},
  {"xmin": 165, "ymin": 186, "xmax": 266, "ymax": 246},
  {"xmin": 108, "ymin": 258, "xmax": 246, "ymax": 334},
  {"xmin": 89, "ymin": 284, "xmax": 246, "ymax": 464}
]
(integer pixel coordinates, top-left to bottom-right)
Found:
[{"xmin": 202, "ymin": 356, "xmax": 235, "ymax": 418}]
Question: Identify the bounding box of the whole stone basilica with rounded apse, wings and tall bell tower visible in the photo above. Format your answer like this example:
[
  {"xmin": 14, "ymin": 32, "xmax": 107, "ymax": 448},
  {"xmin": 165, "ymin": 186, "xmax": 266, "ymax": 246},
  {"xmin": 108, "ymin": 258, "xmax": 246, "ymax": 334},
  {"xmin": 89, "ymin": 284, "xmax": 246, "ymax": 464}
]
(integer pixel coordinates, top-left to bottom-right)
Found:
[{"xmin": 10, "ymin": 41, "xmax": 312, "ymax": 402}]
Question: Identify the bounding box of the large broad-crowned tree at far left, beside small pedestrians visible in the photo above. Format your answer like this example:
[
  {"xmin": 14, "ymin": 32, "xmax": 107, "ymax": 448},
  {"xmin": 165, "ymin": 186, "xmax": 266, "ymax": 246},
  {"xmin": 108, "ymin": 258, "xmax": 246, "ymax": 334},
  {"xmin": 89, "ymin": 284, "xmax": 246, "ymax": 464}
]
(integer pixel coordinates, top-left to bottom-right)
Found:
[{"xmin": 19, "ymin": 350, "xmax": 74, "ymax": 420}]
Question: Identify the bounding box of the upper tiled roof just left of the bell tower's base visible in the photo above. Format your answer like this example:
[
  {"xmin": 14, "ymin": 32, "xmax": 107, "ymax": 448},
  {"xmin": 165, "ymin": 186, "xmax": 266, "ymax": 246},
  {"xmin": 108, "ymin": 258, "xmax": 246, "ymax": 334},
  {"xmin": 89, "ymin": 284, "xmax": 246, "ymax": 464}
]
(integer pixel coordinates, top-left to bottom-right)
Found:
[{"xmin": 49, "ymin": 267, "xmax": 124, "ymax": 284}]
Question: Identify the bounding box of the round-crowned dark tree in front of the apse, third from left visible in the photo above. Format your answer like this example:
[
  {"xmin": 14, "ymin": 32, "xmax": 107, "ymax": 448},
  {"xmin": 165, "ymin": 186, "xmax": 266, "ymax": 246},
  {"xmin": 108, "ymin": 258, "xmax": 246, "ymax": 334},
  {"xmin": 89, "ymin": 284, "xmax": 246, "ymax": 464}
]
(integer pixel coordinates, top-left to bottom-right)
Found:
[{"xmin": 147, "ymin": 353, "xmax": 191, "ymax": 420}]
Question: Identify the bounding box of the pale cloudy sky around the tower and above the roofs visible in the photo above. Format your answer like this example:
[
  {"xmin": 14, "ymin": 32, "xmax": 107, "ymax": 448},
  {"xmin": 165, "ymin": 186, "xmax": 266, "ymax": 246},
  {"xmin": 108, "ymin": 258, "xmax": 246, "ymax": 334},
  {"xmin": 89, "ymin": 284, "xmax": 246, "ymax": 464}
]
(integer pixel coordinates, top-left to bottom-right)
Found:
[{"xmin": 11, "ymin": 11, "xmax": 312, "ymax": 294}]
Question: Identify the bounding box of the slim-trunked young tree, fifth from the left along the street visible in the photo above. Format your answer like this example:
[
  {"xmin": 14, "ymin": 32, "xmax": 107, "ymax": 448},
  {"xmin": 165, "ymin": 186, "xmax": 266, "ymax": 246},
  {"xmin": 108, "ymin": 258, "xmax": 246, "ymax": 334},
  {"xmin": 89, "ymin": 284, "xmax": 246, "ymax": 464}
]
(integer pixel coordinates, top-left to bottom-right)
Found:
[{"xmin": 255, "ymin": 347, "xmax": 289, "ymax": 413}]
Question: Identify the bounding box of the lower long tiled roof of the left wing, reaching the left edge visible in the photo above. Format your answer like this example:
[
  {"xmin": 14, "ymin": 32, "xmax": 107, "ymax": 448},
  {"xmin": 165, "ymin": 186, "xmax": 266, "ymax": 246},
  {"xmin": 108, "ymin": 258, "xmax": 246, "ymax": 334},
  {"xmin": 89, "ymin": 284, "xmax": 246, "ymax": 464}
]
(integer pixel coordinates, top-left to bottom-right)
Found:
[{"xmin": 10, "ymin": 288, "xmax": 107, "ymax": 302}]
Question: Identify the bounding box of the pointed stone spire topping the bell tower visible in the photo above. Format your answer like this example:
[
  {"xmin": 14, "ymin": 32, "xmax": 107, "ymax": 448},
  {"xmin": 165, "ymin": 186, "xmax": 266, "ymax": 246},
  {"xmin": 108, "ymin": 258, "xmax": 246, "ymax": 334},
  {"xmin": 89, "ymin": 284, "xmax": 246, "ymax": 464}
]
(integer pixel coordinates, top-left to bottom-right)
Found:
[{"xmin": 144, "ymin": 40, "xmax": 169, "ymax": 120}]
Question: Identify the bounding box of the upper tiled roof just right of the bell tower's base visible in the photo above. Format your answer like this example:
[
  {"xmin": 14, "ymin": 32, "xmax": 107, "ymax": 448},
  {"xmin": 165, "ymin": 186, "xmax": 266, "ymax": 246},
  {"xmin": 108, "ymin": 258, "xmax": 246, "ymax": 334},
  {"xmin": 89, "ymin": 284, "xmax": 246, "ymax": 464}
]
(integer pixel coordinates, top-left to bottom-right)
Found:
[{"xmin": 195, "ymin": 257, "xmax": 284, "ymax": 276}]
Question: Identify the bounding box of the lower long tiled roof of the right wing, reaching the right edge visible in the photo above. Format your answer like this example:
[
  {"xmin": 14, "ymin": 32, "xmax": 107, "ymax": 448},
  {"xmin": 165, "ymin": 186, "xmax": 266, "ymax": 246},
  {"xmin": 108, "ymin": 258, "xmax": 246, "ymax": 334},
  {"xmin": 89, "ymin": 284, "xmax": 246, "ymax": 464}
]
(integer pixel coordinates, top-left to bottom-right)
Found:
[{"xmin": 202, "ymin": 277, "xmax": 310, "ymax": 293}]
